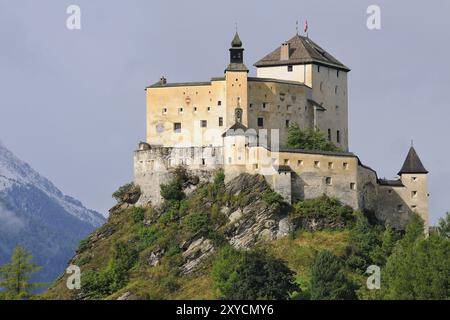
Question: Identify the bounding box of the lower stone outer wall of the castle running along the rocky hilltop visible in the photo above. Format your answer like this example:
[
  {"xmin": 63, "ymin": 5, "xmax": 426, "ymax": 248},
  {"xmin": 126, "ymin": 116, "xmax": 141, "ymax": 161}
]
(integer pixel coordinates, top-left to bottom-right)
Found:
[{"xmin": 134, "ymin": 144, "xmax": 428, "ymax": 229}]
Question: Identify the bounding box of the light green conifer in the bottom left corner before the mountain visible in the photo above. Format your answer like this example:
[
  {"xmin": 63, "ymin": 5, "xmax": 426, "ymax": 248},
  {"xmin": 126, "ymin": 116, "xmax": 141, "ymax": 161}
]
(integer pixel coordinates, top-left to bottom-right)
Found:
[{"xmin": 0, "ymin": 246, "xmax": 41, "ymax": 300}]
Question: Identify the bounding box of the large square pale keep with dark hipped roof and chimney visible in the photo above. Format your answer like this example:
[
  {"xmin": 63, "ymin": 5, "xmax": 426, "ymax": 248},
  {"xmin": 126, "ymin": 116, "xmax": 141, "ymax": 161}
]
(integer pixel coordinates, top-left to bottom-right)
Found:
[{"xmin": 254, "ymin": 34, "xmax": 350, "ymax": 151}]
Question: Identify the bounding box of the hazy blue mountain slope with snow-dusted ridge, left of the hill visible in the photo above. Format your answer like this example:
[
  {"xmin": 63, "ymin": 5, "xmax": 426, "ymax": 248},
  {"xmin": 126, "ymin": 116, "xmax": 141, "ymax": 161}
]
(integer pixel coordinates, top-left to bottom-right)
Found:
[{"xmin": 0, "ymin": 141, "xmax": 105, "ymax": 282}]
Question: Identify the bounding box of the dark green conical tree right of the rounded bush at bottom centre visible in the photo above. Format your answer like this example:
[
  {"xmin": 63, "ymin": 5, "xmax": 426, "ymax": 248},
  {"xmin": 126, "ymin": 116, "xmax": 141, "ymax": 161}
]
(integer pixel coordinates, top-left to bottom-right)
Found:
[{"xmin": 311, "ymin": 250, "xmax": 356, "ymax": 300}]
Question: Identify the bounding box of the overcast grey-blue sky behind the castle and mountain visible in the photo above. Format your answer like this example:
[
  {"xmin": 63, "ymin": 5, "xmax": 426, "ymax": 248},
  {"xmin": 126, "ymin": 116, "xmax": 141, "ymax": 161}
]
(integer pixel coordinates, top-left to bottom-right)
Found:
[{"xmin": 0, "ymin": 0, "xmax": 450, "ymax": 223}]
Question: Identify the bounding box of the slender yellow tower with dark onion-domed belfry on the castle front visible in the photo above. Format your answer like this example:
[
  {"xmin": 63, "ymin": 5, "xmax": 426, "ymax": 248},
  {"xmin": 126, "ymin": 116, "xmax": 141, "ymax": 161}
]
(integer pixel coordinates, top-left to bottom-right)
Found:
[{"xmin": 225, "ymin": 32, "xmax": 248, "ymax": 127}]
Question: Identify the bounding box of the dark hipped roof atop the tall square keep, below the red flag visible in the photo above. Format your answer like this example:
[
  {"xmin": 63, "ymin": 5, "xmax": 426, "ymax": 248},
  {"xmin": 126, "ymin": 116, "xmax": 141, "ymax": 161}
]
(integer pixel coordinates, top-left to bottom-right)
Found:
[{"xmin": 254, "ymin": 35, "xmax": 350, "ymax": 71}]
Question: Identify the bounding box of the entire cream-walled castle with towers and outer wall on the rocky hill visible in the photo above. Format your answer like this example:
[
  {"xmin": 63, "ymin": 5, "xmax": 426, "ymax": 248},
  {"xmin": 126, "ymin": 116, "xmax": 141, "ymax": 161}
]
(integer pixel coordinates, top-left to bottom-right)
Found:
[{"xmin": 134, "ymin": 32, "xmax": 428, "ymax": 228}]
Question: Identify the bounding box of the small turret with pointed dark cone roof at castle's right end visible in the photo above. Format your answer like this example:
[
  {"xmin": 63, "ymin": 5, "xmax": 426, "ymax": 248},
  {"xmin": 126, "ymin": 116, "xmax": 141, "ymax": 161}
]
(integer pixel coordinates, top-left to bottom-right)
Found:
[{"xmin": 398, "ymin": 146, "xmax": 429, "ymax": 232}]
